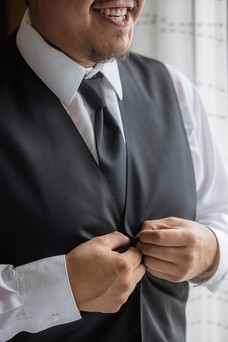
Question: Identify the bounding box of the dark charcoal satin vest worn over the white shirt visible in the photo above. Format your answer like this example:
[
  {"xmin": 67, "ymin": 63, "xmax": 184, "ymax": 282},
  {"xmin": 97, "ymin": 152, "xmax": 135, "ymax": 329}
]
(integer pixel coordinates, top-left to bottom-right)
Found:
[{"xmin": 0, "ymin": 32, "xmax": 196, "ymax": 342}]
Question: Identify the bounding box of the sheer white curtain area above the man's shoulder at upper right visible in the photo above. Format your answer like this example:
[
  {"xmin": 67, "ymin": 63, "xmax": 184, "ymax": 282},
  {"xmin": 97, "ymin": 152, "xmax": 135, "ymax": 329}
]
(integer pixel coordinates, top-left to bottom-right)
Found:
[{"xmin": 132, "ymin": 0, "xmax": 228, "ymax": 161}]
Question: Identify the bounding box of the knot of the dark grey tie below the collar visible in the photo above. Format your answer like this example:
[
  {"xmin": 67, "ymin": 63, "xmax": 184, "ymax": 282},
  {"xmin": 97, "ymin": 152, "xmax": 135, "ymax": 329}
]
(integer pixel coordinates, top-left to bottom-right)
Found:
[{"xmin": 79, "ymin": 72, "xmax": 106, "ymax": 110}]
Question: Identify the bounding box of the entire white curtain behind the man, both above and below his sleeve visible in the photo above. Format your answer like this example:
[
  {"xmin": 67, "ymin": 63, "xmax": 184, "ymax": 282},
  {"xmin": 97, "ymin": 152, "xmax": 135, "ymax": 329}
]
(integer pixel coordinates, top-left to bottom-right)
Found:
[{"xmin": 132, "ymin": 0, "xmax": 228, "ymax": 342}]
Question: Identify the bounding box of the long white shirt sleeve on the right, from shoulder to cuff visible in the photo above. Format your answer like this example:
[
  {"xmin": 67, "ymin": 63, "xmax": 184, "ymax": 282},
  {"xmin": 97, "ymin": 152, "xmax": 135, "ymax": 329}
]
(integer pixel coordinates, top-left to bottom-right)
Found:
[{"xmin": 167, "ymin": 65, "xmax": 228, "ymax": 291}]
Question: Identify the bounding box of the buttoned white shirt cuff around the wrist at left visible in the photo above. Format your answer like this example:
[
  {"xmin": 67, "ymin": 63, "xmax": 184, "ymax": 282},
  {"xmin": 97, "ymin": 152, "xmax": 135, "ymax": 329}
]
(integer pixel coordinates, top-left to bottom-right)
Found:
[{"xmin": 15, "ymin": 255, "xmax": 81, "ymax": 333}]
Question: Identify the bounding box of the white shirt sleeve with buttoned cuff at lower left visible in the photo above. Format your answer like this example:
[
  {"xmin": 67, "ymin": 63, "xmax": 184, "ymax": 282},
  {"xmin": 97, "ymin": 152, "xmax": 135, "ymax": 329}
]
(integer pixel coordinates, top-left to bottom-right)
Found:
[{"xmin": 0, "ymin": 255, "xmax": 81, "ymax": 342}]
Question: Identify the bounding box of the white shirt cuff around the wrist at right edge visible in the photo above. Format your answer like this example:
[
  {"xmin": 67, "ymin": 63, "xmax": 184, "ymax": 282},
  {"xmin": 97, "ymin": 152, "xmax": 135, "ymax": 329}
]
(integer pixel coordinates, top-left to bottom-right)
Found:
[{"xmin": 201, "ymin": 227, "xmax": 228, "ymax": 292}]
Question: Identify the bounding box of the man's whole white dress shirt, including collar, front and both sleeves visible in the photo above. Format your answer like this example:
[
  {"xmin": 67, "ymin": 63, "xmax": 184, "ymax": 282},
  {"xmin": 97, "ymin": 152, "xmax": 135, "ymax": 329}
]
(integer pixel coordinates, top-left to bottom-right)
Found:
[{"xmin": 0, "ymin": 10, "xmax": 228, "ymax": 342}]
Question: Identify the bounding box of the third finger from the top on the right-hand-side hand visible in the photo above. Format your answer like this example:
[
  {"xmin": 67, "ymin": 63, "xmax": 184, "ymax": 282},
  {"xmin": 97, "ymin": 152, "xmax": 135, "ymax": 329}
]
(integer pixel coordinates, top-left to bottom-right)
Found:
[{"xmin": 137, "ymin": 242, "xmax": 186, "ymax": 262}]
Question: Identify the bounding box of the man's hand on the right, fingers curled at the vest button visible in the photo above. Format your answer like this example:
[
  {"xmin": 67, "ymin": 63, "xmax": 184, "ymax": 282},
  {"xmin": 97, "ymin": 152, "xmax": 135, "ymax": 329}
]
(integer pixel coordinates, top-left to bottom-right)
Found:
[{"xmin": 136, "ymin": 217, "xmax": 219, "ymax": 283}]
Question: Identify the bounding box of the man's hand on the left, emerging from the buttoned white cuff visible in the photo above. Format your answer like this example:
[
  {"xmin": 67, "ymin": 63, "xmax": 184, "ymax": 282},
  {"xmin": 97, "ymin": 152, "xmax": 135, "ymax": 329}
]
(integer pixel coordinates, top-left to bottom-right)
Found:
[{"xmin": 66, "ymin": 232, "xmax": 145, "ymax": 313}]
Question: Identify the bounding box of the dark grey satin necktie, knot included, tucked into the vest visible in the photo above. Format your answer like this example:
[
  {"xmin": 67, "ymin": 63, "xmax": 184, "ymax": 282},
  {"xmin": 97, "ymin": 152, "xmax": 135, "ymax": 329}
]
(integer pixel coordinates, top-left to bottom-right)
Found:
[{"xmin": 79, "ymin": 72, "xmax": 126, "ymax": 216}]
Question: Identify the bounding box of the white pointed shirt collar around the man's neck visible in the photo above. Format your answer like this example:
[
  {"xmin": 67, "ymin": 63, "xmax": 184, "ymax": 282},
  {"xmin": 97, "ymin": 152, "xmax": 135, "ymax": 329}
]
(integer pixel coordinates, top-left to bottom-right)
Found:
[{"xmin": 17, "ymin": 9, "xmax": 123, "ymax": 106}]
